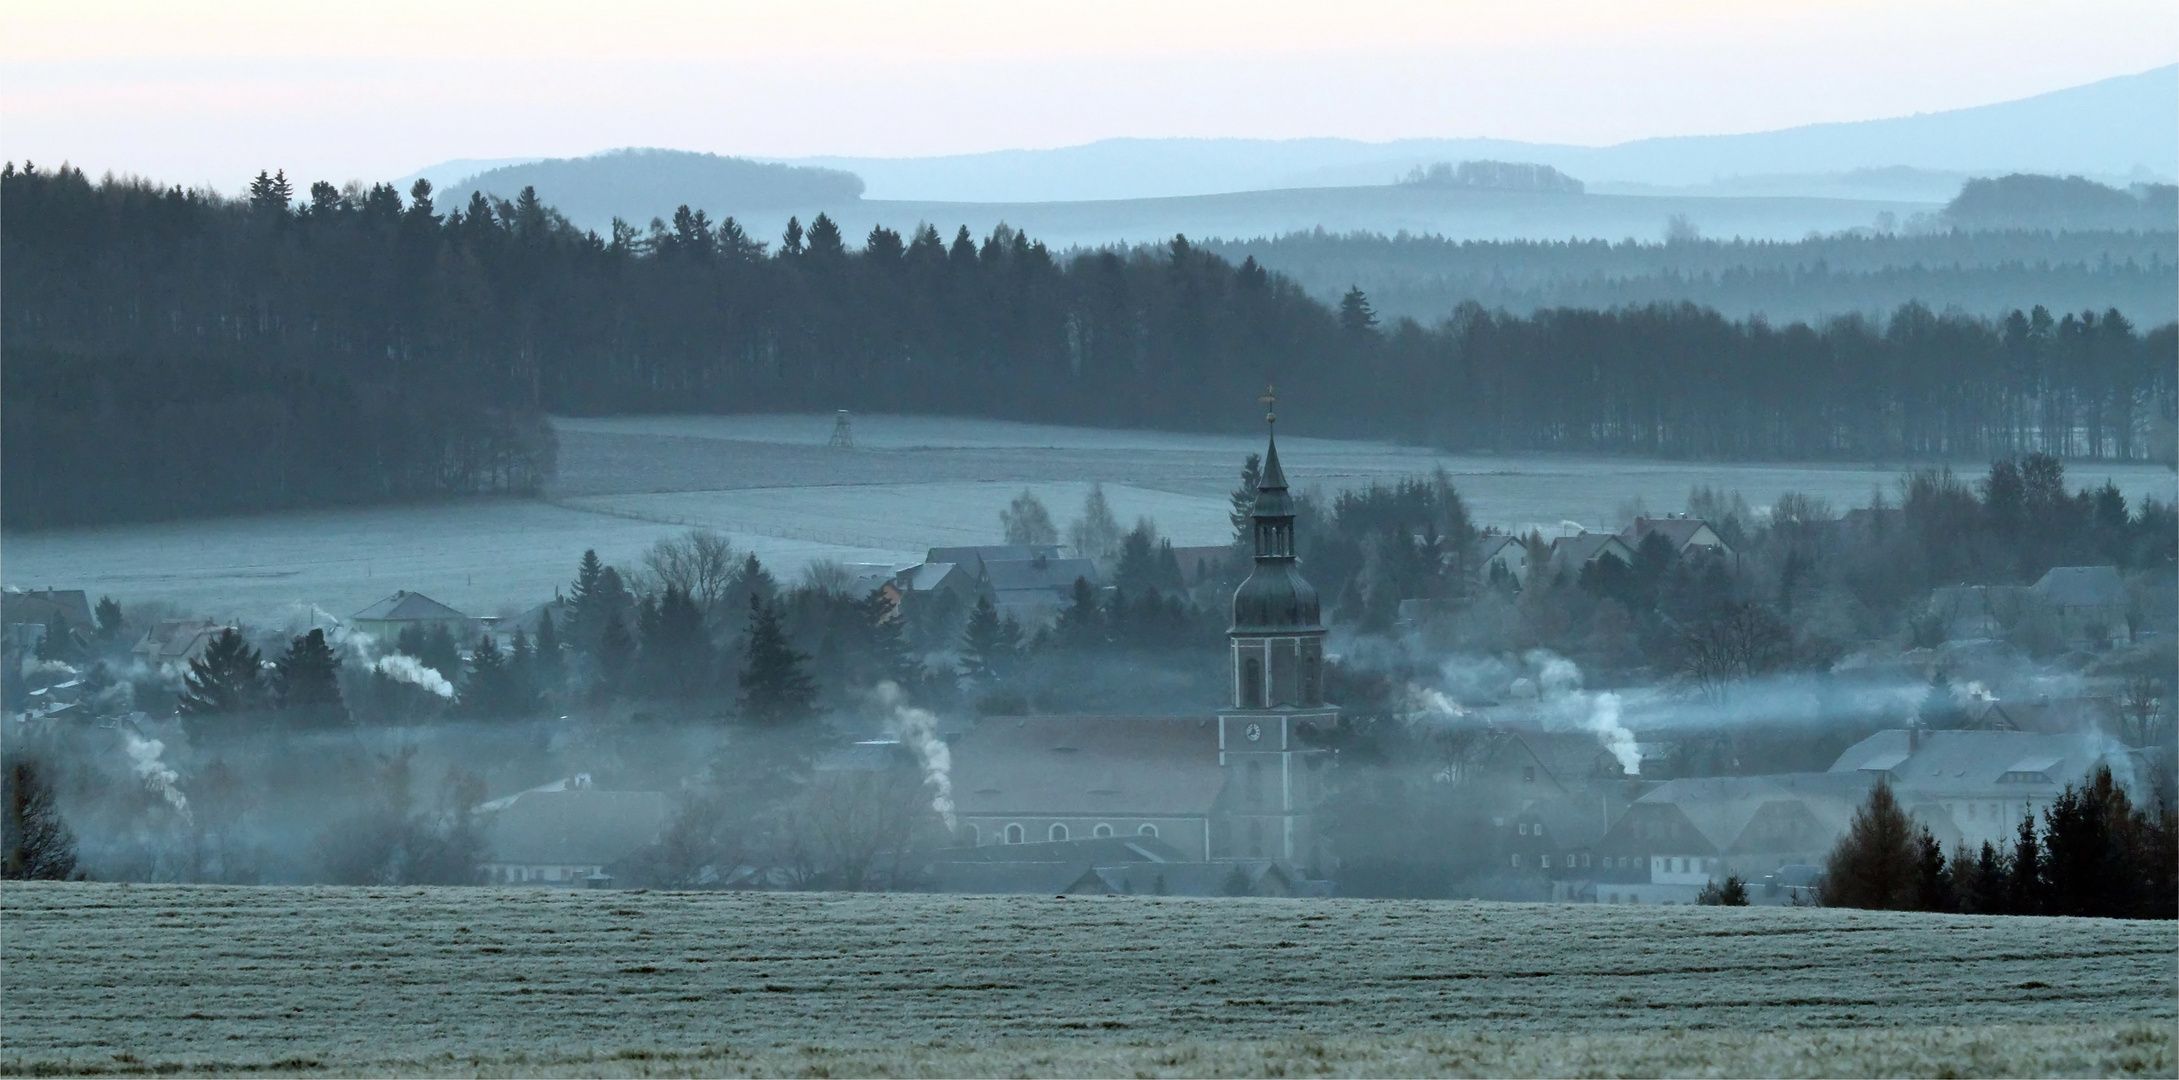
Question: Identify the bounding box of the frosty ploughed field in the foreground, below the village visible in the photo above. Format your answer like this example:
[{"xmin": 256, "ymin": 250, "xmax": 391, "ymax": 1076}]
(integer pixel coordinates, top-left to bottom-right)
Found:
[{"xmin": 0, "ymin": 882, "xmax": 2179, "ymax": 1076}]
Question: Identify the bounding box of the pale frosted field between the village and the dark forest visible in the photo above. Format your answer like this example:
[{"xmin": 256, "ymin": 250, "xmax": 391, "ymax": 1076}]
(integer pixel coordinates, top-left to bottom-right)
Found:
[{"xmin": 0, "ymin": 416, "xmax": 2175, "ymax": 623}]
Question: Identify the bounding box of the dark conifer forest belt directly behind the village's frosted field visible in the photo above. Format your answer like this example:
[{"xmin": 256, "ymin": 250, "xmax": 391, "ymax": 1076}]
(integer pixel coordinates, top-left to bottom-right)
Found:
[{"xmin": 0, "ymin": 163, "xmax": 2179, "ymax": 527}]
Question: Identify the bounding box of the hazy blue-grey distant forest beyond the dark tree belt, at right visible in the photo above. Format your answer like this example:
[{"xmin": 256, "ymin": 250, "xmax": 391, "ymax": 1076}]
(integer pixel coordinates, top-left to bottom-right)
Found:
[{"xmin": 1203, "ymin": 229, "xmax": 2179, "ymax": 324}]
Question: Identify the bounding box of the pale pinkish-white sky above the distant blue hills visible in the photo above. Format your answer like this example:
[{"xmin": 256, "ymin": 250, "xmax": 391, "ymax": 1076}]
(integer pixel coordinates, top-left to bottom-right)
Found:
[{"xmin": 0, "ymin": 0, "xmax": 2179, "ymax": 192}]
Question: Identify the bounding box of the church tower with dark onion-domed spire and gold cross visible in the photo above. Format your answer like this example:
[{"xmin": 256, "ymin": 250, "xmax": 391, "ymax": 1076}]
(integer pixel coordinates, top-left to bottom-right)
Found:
[{"xmin": 1214, "ymin": 392, "xmax": 1340, "ymax": 867}]
